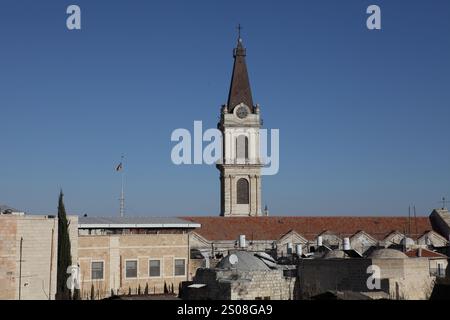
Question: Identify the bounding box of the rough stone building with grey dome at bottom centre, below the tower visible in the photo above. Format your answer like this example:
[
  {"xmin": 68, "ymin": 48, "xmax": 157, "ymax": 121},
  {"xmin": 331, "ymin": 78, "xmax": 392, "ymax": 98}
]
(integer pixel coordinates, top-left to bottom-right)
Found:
[{"xmin": 182, "ymin": 251, "xmax": 296, "ymax": 300}]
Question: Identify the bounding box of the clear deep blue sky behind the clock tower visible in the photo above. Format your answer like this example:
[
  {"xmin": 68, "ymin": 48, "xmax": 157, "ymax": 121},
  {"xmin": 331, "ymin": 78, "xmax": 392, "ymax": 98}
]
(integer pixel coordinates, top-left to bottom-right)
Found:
[{"xmin": 0, "ymin": 0, "xmax": 450, "ymax": 216}]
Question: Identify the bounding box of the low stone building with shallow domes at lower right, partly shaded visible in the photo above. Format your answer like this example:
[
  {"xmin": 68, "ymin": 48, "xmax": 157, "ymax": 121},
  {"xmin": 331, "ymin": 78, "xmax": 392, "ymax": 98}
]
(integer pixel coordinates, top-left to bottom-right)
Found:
[{"xmin": 298, "ymin": 249, "xmax": 435, "ymax": 300}]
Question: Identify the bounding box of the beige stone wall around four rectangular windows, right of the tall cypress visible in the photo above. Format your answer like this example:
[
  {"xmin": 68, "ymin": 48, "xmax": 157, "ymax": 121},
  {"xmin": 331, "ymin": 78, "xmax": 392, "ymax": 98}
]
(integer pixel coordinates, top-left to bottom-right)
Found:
[{"xmin": 78, "ymin": 233, "xmax": 190, "ymax": 299}]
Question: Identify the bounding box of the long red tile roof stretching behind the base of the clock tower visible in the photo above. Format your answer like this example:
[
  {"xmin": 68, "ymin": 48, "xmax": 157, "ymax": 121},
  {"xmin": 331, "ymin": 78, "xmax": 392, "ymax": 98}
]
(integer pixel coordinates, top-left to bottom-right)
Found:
[{"xmin": 182, "ymin": 216, "xmax": 432, "ymax": 241}]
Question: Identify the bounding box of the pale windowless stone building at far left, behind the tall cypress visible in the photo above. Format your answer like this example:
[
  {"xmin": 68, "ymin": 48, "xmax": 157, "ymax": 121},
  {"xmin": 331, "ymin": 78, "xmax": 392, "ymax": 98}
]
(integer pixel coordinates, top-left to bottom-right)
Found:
[{"xmin": 0, "ymin": 210, "xmax": 78, "ymax": 300}]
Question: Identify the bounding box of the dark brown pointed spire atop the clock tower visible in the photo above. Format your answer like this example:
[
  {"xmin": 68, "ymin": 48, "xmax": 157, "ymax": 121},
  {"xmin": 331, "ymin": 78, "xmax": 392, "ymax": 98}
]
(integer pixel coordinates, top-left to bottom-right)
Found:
[{"xmin": 227, "ymin": 29, "xmax": 253, "ymax": 112}]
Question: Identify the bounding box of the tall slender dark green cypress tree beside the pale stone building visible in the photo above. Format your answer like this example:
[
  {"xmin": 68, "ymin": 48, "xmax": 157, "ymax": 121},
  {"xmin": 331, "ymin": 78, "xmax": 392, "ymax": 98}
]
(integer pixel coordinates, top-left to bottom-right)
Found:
[{"xmin": 56, "ymin": 190, "xmax": 72, "ymax": 300}]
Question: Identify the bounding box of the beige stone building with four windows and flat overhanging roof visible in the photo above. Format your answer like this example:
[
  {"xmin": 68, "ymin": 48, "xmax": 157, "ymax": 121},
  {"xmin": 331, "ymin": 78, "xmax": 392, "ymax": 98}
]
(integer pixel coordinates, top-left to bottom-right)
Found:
[{"xmin": 78, "ymin": 217, "xmax": 200, "ymax": 298}]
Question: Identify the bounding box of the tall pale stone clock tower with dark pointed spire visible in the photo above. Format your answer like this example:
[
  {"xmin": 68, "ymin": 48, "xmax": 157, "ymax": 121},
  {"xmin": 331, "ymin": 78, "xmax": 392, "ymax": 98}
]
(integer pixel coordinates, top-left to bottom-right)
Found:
[{"xmin": 217, "ymin": 36, "xmax": 262, "ymax": 217}]
